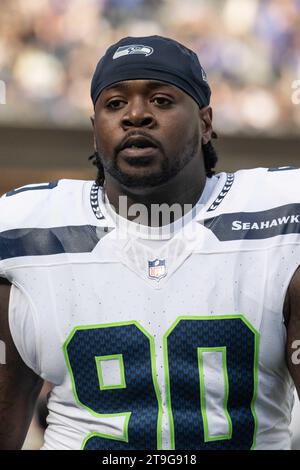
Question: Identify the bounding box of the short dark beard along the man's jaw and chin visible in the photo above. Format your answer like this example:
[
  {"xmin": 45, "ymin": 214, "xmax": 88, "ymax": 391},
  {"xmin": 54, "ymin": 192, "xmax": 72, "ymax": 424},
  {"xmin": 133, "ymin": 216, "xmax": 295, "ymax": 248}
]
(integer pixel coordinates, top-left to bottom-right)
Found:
[{"xmin": 98, "ymin": 130, "xmax": 200, "ymax": 188}]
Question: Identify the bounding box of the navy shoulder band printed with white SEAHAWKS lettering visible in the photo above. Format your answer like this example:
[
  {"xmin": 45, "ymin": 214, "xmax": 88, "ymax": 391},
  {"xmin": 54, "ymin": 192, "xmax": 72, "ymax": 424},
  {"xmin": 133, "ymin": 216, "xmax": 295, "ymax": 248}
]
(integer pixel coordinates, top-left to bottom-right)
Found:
[{"xmin": 204, "ymin": 204, "xmax": 300, "ymax": 241}]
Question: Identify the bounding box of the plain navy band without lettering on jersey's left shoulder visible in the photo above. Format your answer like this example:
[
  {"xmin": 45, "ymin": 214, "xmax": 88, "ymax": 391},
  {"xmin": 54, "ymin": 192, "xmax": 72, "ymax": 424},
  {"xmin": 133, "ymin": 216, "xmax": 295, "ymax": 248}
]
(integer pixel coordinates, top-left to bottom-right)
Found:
[{"xmin": 0, "ymin": 225, "xmax": 110, "ymax": 260}]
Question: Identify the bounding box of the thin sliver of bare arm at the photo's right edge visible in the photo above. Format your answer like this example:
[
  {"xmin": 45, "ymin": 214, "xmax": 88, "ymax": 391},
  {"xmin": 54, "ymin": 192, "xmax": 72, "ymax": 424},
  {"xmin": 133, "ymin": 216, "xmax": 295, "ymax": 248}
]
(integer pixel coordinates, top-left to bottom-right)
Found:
[{"xmin": 284, "ymin": 268, "xmax": 300, "ymax": 399}]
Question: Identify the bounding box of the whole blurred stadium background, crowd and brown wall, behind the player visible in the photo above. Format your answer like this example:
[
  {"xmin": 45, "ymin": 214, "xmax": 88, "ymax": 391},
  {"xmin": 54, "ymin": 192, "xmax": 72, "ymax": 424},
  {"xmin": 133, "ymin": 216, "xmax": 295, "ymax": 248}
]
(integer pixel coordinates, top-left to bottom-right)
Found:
[{"xmin": 0, "ymin": 0, "xmax": 300, "ymax": 448}]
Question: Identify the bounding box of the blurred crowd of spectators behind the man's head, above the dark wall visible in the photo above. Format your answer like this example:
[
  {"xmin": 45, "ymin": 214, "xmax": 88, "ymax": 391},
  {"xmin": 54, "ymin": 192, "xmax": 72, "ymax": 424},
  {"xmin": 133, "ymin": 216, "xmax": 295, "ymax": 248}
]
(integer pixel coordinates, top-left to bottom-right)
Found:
[{"xmin": 0, "ymin": 0, "xmax": 300, "ymax": 135}]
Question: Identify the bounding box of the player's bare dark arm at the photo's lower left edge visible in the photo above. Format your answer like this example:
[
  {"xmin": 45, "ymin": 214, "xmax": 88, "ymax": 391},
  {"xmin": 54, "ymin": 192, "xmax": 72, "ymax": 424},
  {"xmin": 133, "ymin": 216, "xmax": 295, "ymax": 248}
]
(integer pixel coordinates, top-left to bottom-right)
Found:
[{"xmin": 0, "ymin": 283, "xmax": 43, "ymax": 450}]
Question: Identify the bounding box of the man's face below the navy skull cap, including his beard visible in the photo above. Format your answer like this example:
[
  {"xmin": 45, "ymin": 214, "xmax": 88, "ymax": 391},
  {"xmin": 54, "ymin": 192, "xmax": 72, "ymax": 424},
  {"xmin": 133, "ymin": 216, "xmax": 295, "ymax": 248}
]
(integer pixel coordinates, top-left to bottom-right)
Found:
[{"xmin": 94, "ymin": 80, "xmax": 209, "ymax": 188}]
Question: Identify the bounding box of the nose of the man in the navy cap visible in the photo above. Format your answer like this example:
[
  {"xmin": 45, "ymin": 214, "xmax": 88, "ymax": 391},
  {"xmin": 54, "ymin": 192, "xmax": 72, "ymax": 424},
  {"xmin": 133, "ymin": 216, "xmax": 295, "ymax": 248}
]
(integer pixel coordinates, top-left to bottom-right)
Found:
[{"xmin": 122, "ymin": 97, "xmax": 156, "ymax": 130}]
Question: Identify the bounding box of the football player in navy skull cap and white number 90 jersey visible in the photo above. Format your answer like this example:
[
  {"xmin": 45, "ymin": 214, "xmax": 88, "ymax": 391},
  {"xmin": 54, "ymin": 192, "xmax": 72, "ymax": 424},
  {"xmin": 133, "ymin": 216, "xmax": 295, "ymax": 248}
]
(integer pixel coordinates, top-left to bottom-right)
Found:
[{"xmin": 0, "ymin": 36, "xmax": 300, "ymax": 450}]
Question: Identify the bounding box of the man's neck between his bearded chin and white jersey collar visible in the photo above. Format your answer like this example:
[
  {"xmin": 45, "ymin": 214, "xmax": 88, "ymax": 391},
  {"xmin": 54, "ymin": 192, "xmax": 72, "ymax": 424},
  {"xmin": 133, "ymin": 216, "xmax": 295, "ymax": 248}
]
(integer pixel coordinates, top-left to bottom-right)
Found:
[{"xmin": 105, "ymin": 158, "xmax": 206, "ymax": 227}]
